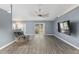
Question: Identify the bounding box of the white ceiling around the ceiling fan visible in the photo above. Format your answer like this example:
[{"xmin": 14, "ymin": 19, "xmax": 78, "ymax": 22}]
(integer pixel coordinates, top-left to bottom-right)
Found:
[{"xmin": 0, "ymin": 4, "xmax": 78, "ymax": 21}]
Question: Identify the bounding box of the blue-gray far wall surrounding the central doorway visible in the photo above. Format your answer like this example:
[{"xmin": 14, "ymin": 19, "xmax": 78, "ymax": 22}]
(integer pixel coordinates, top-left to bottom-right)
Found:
[{"xmin": 13, "ymin": 21, "xmax": 53, "ymax": 34}]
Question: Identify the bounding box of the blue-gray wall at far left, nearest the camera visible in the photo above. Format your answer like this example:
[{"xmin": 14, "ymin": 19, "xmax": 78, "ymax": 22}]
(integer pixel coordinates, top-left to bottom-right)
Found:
[{"xmin": 0, "ymin": 9, "xmax": 13, "ymax": 47}]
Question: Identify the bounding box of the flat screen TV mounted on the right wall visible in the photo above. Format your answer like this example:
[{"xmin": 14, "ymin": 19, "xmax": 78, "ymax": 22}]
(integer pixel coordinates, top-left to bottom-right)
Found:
[{"xmin": 58, "ymin": 21, "xmax": 71, "ymax": 35}]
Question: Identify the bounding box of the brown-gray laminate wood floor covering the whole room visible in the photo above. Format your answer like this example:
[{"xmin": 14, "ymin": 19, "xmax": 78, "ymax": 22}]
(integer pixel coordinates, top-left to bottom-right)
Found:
[{"xmin": 0, "ymin": 35, "xmax": 79, "ymax": 54}]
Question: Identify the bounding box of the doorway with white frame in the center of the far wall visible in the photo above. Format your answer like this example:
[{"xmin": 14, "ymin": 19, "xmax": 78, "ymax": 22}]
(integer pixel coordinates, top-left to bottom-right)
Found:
[{"xmin": 35, "ymin": 23, "xmax": 45, "ymax": 34}]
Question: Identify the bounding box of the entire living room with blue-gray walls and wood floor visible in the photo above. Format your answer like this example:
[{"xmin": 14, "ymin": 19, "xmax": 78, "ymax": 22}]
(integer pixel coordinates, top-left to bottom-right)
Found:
[{"xmin": 0, "ymin": 4, "xmax": 79, "ymax": 54}]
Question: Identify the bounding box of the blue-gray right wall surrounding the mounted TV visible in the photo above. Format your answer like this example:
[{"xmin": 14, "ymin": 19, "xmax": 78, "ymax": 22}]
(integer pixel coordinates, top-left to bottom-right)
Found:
[{"xmin": 53, "ymin": 7, "xmax": 79, "ymax": 47}]
